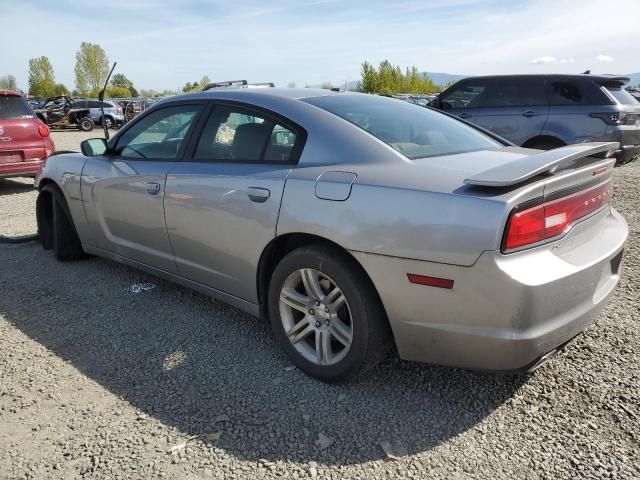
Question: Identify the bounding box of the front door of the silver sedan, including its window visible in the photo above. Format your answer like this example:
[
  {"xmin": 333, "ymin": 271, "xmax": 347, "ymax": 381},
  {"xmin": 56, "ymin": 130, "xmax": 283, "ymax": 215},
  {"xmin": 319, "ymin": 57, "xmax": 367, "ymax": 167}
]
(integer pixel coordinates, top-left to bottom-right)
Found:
[{"xmin": 82, "ymin": 102, "xmax": 204, "ymax": 272}]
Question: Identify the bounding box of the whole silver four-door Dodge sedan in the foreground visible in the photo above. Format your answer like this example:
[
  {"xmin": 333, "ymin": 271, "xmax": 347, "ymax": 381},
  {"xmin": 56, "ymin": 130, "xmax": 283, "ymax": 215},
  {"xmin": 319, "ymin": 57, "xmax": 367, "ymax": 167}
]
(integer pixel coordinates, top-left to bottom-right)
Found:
[{"xmin": 36, "ymin": 88, "xmax": 628, "ymax": 381}]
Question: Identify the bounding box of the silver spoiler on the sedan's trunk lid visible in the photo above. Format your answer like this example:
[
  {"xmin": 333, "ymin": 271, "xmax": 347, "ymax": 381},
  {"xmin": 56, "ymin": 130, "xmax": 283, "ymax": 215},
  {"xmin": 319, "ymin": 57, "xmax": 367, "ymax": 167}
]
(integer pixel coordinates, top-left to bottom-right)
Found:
[{"xmin": 464, "ymin": 142, "xmax": 620, "ymax": 187}]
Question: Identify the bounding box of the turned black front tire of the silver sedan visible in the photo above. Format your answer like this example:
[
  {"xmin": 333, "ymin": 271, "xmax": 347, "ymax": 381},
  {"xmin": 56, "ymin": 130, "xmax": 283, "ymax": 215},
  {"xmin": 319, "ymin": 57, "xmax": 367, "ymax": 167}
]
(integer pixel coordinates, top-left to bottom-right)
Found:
[{"xmin": 38, "ymin": 184, "xmax": 84, "ymax": 261}]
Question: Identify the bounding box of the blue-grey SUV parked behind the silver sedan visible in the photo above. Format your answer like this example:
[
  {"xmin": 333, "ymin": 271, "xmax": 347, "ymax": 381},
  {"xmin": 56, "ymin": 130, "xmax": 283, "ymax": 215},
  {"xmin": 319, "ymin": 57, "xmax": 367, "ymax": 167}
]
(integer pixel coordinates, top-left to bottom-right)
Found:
[{"xmin": 431, "ymin": 74, "xmax": 640, "ymax": 165}]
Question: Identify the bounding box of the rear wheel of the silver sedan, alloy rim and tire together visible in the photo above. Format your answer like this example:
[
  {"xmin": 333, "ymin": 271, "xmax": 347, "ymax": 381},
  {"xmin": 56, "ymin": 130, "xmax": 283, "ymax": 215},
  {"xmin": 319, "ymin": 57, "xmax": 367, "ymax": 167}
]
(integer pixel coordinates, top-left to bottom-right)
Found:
[{"xmin": 268, "ymin": 245, "xmax": 391, "ymax": 383}]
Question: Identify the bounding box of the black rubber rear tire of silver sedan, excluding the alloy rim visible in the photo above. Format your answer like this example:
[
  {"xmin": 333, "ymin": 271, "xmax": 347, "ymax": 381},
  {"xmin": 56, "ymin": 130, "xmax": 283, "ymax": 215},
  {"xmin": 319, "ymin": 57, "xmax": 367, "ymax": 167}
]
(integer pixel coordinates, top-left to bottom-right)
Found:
[{"xmin": 268, "ymin": 244, "xmax": 392, "ymax": 383}]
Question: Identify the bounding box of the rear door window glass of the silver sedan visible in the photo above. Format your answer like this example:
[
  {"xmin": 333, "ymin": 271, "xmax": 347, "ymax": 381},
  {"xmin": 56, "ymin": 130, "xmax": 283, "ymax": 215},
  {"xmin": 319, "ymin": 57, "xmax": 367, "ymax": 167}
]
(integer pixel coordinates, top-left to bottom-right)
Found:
[{"xmin": 194, "ymin": 105, "xmax": 297, "ymax": 163}]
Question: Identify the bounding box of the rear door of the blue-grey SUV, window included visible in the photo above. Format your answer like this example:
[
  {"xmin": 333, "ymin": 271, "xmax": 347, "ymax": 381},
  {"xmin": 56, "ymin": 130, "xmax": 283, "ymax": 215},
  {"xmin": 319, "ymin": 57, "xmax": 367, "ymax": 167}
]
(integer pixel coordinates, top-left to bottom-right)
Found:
[{"xmin": 475, "ymin": 77, "xmax": 549, "ymax": 145}]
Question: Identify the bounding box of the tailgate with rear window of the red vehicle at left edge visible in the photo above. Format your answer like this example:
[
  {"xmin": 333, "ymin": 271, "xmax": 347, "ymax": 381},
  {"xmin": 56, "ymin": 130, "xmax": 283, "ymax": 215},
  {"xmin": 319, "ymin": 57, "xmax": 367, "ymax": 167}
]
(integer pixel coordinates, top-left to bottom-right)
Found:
[{"xmin": 0, "ymin": 95, "xmax": 45, "ymax": 164}]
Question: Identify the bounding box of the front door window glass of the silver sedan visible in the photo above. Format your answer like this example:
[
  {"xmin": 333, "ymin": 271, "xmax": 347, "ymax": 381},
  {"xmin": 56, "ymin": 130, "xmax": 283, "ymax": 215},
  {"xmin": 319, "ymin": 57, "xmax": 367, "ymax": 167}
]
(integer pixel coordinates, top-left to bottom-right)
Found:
[{"xmin": 115, "ymin": 105, "xmax": 202, "ymax": 160}]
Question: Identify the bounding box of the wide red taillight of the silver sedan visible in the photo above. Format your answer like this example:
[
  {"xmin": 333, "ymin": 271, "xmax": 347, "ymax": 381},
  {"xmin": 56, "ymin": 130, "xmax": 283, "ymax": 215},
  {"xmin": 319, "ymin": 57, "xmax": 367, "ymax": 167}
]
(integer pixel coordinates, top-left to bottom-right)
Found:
[{"xmin": 503, "ymin": 179, "xmax": 613, "ymax": 251}]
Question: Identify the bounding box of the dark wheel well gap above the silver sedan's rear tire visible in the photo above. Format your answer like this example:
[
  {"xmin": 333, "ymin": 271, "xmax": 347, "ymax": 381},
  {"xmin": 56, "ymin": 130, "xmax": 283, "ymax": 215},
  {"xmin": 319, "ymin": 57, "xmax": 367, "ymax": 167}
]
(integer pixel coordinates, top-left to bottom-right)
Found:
[{"xmin": 256, "ymin": 233, "xmax": 382, "ymax": 318}]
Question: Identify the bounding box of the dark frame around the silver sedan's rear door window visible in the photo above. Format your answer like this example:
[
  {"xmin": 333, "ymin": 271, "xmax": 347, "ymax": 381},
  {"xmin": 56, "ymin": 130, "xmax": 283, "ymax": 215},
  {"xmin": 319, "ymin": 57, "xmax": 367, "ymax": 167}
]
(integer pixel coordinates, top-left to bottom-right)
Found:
[{"xmin": 181, "ymin": 99, "xmax": 307, "ymax": 165}]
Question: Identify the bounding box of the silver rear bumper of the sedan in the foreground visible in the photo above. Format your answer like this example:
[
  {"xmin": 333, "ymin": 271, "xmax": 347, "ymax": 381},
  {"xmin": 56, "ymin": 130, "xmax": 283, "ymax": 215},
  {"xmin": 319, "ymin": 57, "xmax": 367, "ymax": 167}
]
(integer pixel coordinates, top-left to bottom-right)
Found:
[{"xmin": 354, "ymin": 209, "xmax": 628, "ymax": 370}]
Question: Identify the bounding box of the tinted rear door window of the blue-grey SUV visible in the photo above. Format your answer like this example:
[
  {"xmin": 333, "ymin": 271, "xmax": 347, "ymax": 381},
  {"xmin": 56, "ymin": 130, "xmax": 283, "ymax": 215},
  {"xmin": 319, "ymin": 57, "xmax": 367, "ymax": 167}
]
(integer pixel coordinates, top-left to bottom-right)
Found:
[{"xmin": 478, "ymin": 77, "xmax": 547, "ymax": 107}]
